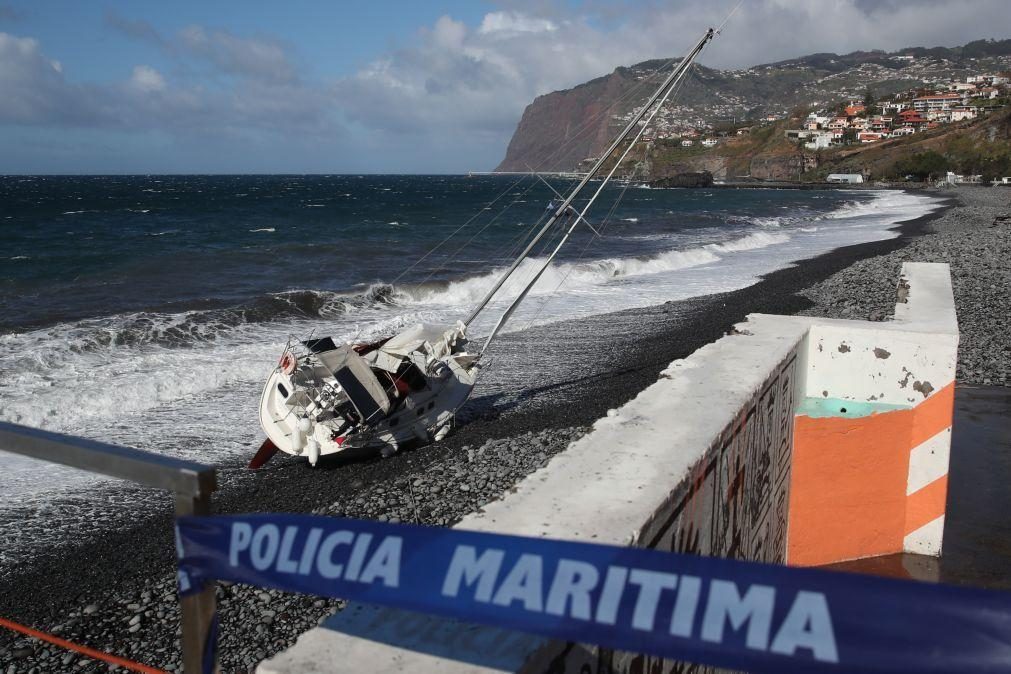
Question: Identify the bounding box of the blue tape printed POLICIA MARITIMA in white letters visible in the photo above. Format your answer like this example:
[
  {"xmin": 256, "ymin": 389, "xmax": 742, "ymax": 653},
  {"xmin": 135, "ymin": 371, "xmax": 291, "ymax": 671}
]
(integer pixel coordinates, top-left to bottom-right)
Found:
[{"xmin": 177, "ymin": 514, "xmax": 1011, "ymax": 672}]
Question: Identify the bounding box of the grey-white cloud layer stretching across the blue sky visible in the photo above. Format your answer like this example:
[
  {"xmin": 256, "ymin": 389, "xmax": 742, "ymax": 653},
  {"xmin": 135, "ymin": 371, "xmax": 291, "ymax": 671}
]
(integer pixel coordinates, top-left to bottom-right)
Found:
[{"xmin": 0, "ymin": 0, "xmax": 1011, "ymax": 171}]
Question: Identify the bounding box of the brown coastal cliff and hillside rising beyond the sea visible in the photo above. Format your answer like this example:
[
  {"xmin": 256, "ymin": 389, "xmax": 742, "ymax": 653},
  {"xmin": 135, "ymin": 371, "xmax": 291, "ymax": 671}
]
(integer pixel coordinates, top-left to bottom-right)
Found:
[{"xmin": 495, "ymin": 40, "xmax": 1011, "ymax": 181}]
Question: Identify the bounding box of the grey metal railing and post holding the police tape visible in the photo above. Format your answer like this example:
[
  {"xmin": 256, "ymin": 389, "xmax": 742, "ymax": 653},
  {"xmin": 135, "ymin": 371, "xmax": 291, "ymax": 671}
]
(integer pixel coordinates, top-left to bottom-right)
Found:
[{"xmin": 0, "ymin": 421, "xmax": 217, "ymax": 674}]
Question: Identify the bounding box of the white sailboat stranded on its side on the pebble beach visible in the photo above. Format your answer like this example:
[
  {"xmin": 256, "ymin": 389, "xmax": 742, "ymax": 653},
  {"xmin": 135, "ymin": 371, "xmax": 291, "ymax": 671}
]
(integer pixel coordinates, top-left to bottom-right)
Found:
[{"xmin": 250, "ymin": 28, "xmax": 716, "ymax": 468}]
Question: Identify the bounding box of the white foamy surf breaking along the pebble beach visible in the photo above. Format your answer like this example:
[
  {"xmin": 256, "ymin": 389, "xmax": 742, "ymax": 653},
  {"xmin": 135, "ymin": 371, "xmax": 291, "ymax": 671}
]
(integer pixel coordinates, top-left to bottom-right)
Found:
[{"xmin": 0, "ymin": 186, "xmax": 937, "ymax": 508}]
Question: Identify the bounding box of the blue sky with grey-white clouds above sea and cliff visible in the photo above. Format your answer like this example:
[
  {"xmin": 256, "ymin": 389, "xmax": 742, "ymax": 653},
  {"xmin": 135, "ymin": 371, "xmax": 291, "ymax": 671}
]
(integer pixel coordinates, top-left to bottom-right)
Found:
[{"xmin": 0, "ymin": 0, "xmax": 1011, "ymax": 174}]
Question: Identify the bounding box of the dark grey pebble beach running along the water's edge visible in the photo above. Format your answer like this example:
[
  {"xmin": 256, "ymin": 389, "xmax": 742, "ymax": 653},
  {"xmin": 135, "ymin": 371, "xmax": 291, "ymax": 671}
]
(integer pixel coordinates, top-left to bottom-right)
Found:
[{"xmin": 0, "ymin": 189, "xmax": 1011, "ymax": 674}]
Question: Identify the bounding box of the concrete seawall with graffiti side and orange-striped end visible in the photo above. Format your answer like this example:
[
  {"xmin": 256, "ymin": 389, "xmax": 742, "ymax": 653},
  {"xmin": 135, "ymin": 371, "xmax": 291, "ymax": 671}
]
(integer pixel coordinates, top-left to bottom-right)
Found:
[{"xmin": 258, "ymin": 264, "xmax": 958, "ymax": 674}]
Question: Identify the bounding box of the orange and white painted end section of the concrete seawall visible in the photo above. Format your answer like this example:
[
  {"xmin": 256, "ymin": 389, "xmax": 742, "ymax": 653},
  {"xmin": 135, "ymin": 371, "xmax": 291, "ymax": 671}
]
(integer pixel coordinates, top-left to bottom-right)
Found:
[{"xmin": 787, "ymin": 263, "xmax": 958, "ymax": 565}]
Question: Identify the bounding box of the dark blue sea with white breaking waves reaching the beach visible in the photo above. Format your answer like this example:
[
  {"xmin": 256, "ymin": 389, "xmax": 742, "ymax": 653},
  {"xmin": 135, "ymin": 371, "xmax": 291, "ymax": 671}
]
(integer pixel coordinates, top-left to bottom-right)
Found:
[{"xmin": 0, "ymin": 175, "xmax": 937, "ymax": 512}]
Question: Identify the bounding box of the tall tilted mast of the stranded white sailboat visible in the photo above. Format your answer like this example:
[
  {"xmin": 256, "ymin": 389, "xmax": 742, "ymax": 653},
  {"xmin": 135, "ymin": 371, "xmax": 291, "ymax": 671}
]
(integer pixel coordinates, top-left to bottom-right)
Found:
[{"xmin": 463, "ymin": 28, "xmax": 715, "ymax": 343}]
